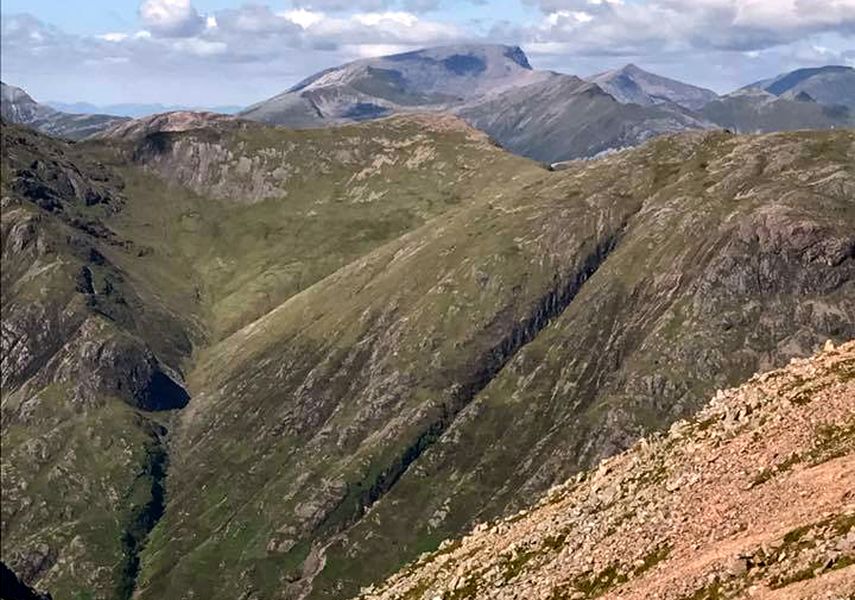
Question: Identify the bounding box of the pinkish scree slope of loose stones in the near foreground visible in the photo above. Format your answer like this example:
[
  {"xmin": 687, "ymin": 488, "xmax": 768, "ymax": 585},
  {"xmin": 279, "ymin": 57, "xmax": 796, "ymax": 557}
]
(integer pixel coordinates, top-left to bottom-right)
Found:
[{"xmin": 359, "ymin": 342, "xmax": 855, "ymax": 600}]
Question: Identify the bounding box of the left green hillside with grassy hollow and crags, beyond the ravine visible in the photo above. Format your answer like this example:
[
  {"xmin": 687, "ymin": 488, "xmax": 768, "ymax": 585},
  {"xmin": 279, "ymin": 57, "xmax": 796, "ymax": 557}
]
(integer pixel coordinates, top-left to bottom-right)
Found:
[{"xmin": 0, "ymin": 114, "xmax": 527, "ymax": 599}]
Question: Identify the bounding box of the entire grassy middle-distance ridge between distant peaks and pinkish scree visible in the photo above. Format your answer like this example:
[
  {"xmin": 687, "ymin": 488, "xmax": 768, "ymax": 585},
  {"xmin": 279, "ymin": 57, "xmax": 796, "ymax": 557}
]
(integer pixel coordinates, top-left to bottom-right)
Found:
[{"xmin": 3, "ymin": 117, "xmax": 855, "ymax": 598}]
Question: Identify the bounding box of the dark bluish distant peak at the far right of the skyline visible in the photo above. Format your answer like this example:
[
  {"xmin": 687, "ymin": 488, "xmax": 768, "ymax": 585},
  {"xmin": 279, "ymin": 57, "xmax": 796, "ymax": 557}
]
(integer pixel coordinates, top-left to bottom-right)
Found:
[{"xmin": 746, "ymin": 66, "xmax": 855, "ymax": 110}]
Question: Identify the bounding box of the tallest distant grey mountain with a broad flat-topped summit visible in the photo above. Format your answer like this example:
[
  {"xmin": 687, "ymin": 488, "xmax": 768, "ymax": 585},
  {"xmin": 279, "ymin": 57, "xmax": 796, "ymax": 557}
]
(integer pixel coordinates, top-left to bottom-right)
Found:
[{"xmin": 241, "ymin": 45, "xmax": 546, "ymax": 127}]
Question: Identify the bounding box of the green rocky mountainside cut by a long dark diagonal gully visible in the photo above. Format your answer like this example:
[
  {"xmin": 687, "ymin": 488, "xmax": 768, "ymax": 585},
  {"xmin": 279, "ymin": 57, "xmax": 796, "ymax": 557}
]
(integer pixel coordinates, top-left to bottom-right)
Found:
[{"xmin": 130, "ymin": 133, "xmax": 855, "ymax": 598}]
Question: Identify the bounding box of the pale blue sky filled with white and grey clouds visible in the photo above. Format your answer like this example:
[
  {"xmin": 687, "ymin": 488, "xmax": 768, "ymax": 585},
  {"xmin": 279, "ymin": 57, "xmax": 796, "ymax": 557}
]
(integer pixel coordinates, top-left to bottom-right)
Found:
[{"xmin": 0, "ymin": 0, "xmax": 855, "ymax": 107}]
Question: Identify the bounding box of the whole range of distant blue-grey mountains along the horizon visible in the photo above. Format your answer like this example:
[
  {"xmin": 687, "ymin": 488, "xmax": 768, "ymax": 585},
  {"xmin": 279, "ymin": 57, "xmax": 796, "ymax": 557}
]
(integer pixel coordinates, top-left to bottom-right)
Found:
[{"xmin": 4, "ymin": 44, "xmax": 855, "ymax": 163}]
